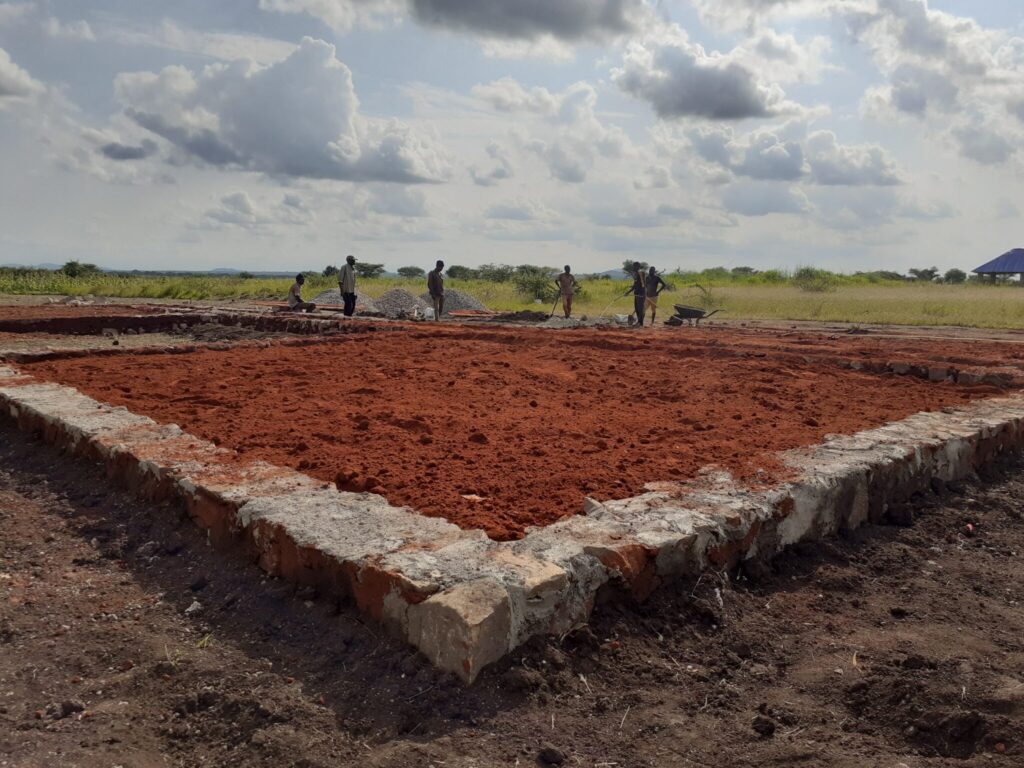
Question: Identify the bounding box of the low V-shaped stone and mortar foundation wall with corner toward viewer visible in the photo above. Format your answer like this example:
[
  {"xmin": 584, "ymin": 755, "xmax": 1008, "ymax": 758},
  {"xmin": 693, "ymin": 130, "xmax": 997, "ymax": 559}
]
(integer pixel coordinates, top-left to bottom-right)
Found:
[{"xmin": 0, "ymin": 366, "xmax": 1024, "ymax": 682}]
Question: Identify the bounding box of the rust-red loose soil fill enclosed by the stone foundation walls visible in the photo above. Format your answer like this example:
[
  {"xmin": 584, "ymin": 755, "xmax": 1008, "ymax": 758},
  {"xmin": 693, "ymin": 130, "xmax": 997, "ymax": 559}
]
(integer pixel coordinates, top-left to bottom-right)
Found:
[{"xmin": 27, "ymin": 327, "xmax": 990, "ymax": 539}]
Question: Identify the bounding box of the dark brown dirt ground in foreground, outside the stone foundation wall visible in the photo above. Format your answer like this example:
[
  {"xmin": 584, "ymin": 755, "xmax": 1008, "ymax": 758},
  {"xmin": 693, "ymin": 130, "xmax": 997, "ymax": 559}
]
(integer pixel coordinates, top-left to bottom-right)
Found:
[{"xmin": 0, "ymin": 424, "xmax": 1024, "ymax": 768}]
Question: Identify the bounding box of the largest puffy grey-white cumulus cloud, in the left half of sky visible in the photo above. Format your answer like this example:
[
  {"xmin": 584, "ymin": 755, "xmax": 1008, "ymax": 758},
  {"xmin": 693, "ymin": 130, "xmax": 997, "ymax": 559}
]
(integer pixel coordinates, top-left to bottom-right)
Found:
[{"xmin": 115, "ymin": 38, "xmax": 450, "ymax": 183}]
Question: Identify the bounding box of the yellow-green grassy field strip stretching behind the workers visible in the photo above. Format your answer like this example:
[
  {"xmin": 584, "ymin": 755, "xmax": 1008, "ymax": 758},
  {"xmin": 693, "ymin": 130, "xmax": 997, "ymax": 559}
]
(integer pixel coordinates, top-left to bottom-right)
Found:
[{"xmin": 0, "ymin": 269, "xmax": 1024, "ymax": 329}]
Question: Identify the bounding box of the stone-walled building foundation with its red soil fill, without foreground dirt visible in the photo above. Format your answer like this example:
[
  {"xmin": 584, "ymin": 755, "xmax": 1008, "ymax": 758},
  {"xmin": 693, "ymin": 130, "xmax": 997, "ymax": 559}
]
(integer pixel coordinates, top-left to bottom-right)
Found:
[{"xmin": 6, "ymin": 307, "xmax": 1024, "ymax": 682}]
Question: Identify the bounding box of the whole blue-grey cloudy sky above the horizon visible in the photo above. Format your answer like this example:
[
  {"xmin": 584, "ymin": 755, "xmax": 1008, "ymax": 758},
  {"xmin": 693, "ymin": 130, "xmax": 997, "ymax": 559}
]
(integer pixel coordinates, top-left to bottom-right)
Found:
[{"xmin": 0, "ymin": 0, "xmax": 1024, "ymax": 272}]
